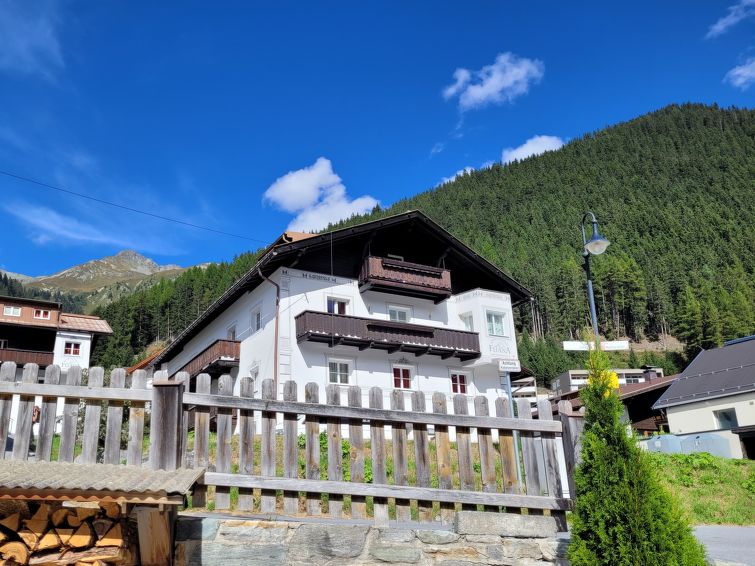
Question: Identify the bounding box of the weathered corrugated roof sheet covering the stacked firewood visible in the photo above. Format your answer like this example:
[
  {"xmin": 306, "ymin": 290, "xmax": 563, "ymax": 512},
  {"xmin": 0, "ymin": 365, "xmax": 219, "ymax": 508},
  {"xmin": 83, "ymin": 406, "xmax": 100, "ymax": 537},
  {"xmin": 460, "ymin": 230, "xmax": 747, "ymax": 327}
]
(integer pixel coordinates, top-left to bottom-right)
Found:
[{"xmin": 0, "ymin": 460, "xmax": 204, "ymax": 496}]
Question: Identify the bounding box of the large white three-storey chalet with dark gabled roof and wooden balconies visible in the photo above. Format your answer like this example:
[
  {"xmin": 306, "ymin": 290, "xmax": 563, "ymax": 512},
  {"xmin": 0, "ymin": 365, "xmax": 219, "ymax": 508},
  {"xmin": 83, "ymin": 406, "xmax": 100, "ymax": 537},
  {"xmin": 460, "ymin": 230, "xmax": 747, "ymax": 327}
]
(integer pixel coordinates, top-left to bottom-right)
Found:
[{"xmin": 152, "ymin": 211, "xmax": 530, "ymax": 411}]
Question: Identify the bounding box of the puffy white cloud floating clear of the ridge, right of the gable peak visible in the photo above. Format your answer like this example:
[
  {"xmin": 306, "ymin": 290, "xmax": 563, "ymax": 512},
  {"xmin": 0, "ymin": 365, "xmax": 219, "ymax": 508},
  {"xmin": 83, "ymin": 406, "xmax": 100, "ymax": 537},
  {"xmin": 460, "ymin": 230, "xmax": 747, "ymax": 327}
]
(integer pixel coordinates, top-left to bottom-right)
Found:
[{"xmin": 443, "ymin": 52, "xmax": 545, "ymax": 112}]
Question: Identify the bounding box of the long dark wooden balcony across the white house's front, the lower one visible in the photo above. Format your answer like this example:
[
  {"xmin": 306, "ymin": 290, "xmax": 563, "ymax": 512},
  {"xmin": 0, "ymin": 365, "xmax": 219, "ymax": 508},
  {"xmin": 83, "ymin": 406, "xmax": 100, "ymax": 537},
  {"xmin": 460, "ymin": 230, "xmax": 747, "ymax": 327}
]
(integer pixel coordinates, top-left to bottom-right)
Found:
[{"xmin": 296, "ymin": 311, "xmax": 480, "ymax": 361}]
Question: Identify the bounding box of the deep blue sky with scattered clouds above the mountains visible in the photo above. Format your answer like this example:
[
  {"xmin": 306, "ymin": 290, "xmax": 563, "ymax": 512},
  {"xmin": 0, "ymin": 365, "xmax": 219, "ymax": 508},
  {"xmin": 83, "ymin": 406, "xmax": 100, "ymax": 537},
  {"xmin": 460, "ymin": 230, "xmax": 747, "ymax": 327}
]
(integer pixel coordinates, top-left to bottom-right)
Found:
[{"xmin": 0, "ymin": 0, "xmax": 755, "ymax": 275}]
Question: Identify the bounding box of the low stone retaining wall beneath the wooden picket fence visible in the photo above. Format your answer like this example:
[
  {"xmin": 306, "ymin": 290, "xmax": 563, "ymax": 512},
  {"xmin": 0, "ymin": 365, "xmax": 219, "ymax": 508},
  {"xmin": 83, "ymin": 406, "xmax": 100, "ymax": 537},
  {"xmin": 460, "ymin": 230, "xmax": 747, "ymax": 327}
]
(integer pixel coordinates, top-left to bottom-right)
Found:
[{"xmin": 175, "ymin": 511, "xmax": 567, "ymax": 566}]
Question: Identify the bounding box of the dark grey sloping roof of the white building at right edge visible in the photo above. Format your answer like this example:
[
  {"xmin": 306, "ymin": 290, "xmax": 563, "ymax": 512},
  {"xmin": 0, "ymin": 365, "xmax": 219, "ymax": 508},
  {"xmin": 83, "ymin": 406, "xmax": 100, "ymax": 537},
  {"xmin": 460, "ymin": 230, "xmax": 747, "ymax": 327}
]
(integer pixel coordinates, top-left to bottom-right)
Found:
[{"xmin": 653, "ymin": 336, "xmax": 755, "ymax": 409}]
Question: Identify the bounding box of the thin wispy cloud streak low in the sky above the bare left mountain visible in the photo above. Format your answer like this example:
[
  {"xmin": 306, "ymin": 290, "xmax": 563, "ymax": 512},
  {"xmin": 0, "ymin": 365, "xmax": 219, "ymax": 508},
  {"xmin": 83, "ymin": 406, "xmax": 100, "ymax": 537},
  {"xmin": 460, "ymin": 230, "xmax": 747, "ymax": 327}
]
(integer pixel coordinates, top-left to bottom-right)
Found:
[{"xmin": 3, "ymin": 202, "xmax": 180, "ymax": 255}]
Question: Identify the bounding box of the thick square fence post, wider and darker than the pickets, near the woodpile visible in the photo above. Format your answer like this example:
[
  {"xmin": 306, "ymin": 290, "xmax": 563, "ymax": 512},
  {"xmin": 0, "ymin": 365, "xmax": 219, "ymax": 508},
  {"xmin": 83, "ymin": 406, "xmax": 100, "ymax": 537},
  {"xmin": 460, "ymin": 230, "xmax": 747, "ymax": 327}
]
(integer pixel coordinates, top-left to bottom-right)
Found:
[{"xmin": 149, "ymin": 371, "xmax": 184, "ymax": 471}]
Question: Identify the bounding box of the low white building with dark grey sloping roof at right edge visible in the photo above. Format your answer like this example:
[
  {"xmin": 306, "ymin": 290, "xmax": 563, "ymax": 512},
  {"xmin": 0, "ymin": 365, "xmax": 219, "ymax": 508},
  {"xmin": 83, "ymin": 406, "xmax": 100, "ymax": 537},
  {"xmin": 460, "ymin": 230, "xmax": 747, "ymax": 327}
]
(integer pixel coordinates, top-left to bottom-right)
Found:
[{"xmin": 653, "ymin": 336, "xmax": 755, "ymax": 458}]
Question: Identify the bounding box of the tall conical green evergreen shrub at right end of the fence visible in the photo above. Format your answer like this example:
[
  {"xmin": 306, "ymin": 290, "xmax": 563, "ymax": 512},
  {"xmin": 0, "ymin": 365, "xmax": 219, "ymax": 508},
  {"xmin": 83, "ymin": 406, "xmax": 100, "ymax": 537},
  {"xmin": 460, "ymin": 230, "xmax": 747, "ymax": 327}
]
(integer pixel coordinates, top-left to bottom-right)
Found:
[{"xmin": 569, "ymin": 344, "xmax": 715, "ymax": 566}]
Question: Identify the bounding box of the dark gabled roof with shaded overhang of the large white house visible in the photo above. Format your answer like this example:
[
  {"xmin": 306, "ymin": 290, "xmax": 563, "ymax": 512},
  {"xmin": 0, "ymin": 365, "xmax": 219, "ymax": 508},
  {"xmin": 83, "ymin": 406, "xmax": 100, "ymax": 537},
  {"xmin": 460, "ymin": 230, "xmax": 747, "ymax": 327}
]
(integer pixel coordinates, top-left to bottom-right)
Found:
[{"xmin": 152, "ymin": 210, "xmax": 532, "ymax": 365}]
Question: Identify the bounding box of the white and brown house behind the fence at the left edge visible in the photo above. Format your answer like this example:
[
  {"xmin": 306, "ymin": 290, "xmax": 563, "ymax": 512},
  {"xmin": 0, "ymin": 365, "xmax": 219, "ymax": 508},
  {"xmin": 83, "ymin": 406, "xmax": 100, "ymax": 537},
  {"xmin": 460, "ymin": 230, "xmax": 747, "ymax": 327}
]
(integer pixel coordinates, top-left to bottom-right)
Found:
[{"xmin": 0, "ymin": 296, "xmax": 113, "ymax": 370}]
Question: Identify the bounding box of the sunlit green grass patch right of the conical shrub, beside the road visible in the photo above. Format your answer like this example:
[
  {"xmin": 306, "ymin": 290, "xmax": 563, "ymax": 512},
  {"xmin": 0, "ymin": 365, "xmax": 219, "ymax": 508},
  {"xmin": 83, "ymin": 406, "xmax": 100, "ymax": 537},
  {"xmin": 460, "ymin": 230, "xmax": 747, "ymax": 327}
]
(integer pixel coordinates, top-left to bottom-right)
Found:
[{"xmin": 650, "ymin": 453, "xmax": 755, "ymax": 525}]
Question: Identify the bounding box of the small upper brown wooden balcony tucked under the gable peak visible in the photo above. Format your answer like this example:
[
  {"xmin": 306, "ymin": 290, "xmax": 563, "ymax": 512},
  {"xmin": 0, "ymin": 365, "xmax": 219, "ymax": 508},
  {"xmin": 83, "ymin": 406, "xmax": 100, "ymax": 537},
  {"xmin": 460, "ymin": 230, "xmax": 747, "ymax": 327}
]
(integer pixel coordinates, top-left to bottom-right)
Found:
[{"xmin": 359, "ymin": 256, "xmax": 451, "ymax": 303}]
